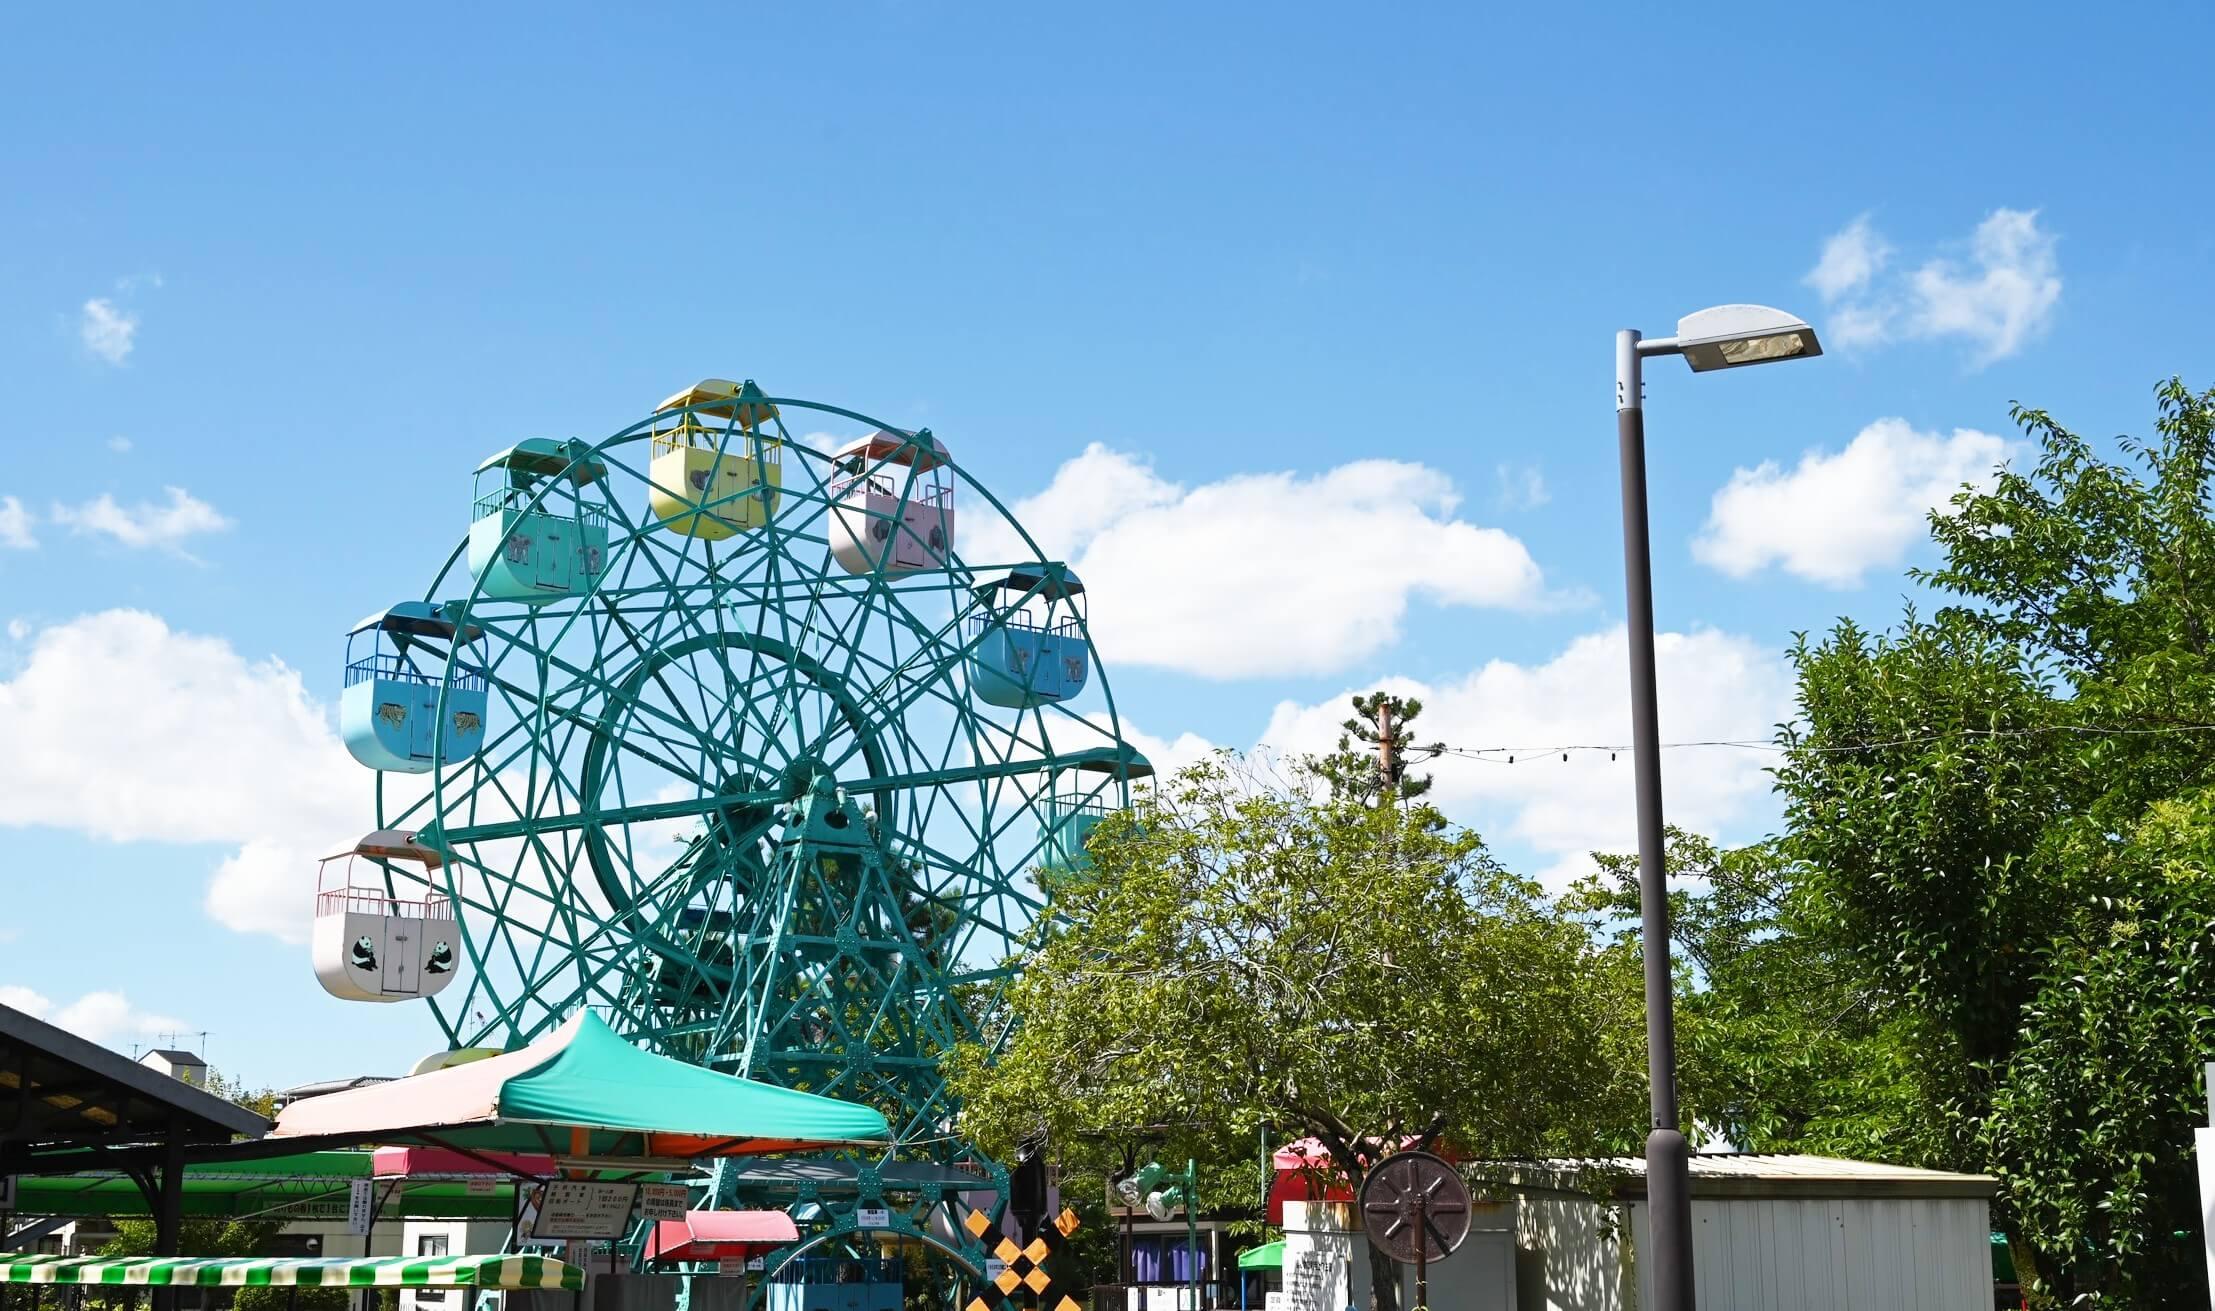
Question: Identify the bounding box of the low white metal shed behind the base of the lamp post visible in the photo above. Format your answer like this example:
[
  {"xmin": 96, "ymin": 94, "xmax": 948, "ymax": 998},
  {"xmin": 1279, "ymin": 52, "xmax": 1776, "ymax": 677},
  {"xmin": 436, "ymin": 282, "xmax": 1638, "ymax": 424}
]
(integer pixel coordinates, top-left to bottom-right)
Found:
[{"xmin": 1473, "ymin": 1154, "xmax": 1998, "ymax": 1311}]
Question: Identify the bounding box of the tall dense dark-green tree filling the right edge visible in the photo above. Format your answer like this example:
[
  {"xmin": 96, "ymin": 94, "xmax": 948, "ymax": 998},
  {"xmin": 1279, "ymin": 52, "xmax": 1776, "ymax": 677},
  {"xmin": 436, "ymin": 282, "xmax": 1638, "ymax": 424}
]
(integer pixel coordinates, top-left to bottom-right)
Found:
[{"xmin": 1776, "ymin": 381, "xmax": 2215, "ymax": 1307}]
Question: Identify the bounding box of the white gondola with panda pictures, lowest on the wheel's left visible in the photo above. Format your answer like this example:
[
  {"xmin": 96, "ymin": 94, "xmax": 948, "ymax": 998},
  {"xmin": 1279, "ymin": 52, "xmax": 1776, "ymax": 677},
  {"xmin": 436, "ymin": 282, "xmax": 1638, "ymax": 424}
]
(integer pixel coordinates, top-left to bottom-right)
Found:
[{"xmin": 312, "ymin": 828, "xmax": 459, "ymax": 1001}]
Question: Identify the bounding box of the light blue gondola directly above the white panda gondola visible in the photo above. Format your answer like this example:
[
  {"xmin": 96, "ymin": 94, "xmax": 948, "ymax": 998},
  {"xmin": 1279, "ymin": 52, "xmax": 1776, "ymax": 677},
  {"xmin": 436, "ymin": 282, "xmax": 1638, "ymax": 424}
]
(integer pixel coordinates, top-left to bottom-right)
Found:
[{"xmin": 339, "ymin": 600, "xmax": 485, "ymax": 773}]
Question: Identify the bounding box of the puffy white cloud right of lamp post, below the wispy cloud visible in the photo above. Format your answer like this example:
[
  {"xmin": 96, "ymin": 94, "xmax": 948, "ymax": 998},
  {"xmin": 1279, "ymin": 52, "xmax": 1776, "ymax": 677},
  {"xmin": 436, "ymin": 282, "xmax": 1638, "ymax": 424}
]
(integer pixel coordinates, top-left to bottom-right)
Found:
[{"xmin": 1692, "ymin": 419, "xmax": 2013, "ymax": 587}]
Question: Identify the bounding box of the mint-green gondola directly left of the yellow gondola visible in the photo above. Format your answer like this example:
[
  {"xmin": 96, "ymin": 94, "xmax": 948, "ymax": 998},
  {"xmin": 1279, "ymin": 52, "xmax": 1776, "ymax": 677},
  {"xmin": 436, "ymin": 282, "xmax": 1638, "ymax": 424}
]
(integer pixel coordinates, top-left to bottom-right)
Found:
[{"xmin": 470, "ymin": 436, "xmax": 607, "ymax": 605}]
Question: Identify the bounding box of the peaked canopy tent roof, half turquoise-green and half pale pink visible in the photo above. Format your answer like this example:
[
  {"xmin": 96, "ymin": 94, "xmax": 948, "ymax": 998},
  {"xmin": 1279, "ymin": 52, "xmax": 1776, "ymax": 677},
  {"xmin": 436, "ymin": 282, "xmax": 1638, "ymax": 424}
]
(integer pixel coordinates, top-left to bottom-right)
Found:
[{"xmin": 270, "ymin": 1012, "xmax": 893, "ymax": 1169}]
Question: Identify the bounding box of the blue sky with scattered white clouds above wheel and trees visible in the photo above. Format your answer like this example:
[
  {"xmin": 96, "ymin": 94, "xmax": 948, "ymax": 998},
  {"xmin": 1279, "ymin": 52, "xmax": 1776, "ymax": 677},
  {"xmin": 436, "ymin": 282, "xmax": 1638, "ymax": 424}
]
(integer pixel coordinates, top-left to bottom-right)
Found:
[{"xmin": 0, "ymin": 4, "xmax": 2215, "ymax": 1083}]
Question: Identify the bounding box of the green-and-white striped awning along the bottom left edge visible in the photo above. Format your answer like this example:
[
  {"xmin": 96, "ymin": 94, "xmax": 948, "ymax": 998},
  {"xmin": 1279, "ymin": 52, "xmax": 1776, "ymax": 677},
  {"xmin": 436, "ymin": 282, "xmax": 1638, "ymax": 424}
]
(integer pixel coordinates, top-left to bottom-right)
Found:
[{"xmin": 0, "ymin": 1256, "xmax": 585, "ymax": 1289}]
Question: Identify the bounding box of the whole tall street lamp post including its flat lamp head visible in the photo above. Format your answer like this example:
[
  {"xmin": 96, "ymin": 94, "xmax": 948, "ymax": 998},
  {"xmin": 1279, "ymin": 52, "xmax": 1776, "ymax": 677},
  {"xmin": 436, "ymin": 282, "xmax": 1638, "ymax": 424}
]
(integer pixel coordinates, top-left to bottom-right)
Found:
[{"xmin": 1615, "ymin": 306, "xmax": 1823, "ymax": 1311}]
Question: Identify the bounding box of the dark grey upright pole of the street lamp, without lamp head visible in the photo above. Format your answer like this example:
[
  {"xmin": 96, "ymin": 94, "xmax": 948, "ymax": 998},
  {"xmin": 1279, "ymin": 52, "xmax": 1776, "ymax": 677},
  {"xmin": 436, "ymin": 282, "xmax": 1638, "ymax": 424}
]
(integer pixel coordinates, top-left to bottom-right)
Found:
[{"xmin": 1615, "ymin": 328, "xmax": 1694, "ymax": 1311}]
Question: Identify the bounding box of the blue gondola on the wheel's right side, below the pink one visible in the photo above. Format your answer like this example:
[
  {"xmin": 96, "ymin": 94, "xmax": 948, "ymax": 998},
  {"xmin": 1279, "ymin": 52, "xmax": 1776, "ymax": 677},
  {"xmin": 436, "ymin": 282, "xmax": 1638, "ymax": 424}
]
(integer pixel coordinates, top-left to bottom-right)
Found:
[{"xmin": 970, "ymin": 565, "xmax": 1092, "ymax": 711}]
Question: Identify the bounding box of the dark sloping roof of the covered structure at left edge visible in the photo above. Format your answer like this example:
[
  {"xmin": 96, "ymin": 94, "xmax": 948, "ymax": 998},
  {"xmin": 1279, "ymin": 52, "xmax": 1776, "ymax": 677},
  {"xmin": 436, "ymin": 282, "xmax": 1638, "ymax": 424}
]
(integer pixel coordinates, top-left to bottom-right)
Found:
[{"xmin": 0, "ymin": 1005, "xmax": 270, "ymax": 1174}]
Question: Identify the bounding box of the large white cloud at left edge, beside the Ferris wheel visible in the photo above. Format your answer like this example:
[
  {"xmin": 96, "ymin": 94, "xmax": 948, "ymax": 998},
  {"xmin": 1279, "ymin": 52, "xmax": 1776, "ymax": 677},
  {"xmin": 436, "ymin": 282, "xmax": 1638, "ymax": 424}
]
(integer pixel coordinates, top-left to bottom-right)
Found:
[{"xmin": 0, "ymin": 611, "xmax": 365, "ymax": 941}]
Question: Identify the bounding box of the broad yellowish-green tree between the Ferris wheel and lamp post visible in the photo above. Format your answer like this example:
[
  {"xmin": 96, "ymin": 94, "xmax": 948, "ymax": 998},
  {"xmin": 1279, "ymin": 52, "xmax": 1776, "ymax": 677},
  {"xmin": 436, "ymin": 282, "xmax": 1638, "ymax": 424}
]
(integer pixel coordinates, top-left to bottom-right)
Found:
[{"xmin": 950, "ymin": 755, "xmax": 1644, "ymax": 1309}]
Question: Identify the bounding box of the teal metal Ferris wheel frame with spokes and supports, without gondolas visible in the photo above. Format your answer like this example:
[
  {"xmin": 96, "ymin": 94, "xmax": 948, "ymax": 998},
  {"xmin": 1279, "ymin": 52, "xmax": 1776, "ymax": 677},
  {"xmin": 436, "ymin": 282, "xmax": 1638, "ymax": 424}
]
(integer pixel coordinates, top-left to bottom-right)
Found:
[{"xmin": 354, "ymin": 383, "xmax": 1152, "ymax": 1160}]
